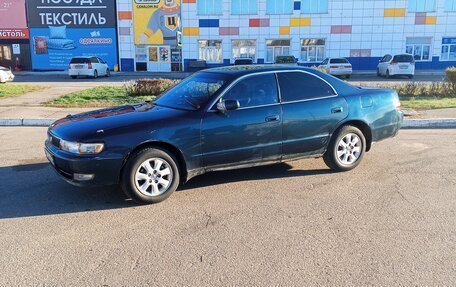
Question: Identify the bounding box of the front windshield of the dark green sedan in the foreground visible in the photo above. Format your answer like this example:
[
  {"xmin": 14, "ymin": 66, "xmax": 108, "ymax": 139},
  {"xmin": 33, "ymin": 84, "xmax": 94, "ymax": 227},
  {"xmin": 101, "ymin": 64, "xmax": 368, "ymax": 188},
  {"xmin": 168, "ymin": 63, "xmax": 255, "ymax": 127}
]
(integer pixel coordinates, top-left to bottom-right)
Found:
[{"xmin": 153, "ymin": 72, "xmax": 226, "ymax": 110}]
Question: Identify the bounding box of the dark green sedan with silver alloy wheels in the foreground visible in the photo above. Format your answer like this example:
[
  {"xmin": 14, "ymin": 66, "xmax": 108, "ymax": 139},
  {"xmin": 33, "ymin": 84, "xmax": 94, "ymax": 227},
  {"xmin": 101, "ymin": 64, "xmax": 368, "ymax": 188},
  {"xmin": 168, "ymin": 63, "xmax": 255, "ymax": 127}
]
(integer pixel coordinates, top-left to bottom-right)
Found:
[{"xmin": 45, "ymin": 65, "xmax": 403, "ymax": 203}]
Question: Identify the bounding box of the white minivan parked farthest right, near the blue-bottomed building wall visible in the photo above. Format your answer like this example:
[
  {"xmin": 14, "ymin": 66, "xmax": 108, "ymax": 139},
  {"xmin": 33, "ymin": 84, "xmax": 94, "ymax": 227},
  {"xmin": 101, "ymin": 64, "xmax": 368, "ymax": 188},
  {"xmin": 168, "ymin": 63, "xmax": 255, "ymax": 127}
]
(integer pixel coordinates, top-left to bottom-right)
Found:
[{"xmin": 377, "ymin": 54, "xmax": 415, "ymax": 79}]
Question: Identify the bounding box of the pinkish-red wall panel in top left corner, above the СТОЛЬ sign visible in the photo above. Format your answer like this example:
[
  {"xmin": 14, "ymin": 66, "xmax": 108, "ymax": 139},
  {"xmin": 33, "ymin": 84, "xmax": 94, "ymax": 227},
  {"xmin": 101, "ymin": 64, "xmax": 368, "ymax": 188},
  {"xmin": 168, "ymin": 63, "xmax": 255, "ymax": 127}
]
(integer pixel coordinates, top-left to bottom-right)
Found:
[{"xmin": 0, "ymin": 0, "xmax": 27, "ymax": 28}]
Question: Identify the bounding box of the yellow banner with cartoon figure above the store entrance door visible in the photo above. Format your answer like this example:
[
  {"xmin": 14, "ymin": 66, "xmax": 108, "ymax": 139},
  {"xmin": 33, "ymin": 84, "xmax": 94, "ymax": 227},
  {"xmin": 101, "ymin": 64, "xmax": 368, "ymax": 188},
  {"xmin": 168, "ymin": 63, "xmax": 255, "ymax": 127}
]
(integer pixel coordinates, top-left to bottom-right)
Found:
[{"xmin": 133, "ymin": 0, "xmax": 181, "ymax": 46}]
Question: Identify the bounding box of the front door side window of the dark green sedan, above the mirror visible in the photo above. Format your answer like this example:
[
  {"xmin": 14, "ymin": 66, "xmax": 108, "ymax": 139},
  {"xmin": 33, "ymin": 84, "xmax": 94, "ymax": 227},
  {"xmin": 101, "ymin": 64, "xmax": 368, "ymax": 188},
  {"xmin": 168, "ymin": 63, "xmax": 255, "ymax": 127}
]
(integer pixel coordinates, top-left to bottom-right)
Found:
[{"xmin": 223, "ymin": 73, "xmax": 279, "ymax": 108}]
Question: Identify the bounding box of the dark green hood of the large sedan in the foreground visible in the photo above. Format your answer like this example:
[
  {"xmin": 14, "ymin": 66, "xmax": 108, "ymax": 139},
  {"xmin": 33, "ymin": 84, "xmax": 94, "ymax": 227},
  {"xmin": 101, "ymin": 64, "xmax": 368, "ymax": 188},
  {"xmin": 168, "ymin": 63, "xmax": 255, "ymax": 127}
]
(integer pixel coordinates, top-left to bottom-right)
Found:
[{"xmin": 49, "ymin": 103, "xmax": 188, "ymax": 142}]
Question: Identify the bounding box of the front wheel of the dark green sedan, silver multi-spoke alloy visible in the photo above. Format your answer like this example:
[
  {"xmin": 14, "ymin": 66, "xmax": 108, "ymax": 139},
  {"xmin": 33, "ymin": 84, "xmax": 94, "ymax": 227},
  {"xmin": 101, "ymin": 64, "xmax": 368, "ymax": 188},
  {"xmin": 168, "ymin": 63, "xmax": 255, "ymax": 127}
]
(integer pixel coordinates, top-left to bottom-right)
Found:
[{"xmin": 121, "ymin": 148, "xmax": 180, "ymax": 204}]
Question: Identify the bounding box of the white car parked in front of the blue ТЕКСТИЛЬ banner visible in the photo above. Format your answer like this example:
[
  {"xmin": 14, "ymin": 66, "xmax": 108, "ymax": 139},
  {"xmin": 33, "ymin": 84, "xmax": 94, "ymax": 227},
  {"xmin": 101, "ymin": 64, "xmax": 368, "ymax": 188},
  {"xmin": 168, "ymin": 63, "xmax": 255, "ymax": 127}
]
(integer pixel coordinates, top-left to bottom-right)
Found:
[{"xmin": 68, "ymin": 57, "xmax": 111, "ymax": 79}]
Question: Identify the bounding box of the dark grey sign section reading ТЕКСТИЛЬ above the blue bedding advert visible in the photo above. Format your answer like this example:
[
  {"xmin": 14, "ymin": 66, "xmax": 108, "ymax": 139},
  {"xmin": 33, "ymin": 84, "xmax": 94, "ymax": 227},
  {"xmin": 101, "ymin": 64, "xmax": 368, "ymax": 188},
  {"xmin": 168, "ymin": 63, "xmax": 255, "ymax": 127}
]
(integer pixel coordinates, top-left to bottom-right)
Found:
[{"xmin": 27, "ymin": 0, "xmax": 116, "ymax": 28}]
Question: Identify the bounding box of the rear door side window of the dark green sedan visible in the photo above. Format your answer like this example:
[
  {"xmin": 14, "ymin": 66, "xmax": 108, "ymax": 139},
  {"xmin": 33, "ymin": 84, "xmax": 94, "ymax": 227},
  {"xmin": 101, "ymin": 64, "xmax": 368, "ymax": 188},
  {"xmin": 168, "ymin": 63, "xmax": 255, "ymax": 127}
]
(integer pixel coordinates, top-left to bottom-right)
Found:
[{"xmin": 277, "ymin": 72, "xmax": 336, "ymax": 103}]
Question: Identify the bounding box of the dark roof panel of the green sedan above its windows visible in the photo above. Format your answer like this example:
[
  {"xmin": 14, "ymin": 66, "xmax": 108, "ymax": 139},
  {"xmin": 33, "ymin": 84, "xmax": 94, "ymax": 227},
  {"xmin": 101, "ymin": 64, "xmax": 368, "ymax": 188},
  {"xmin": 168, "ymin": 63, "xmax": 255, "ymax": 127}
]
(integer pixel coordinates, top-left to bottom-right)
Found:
[{"xmin": 202, "ymin": 64, "xmax": 314, "ymax": 76}]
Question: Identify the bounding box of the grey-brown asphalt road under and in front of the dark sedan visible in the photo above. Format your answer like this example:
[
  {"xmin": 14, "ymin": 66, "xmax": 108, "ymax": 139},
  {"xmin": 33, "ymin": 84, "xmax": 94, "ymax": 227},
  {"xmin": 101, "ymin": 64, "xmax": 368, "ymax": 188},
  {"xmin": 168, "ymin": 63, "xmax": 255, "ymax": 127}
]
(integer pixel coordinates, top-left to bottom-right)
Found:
[{"xmin": 0, "ymin": 128, "xmax": 456, "ymax": 286}]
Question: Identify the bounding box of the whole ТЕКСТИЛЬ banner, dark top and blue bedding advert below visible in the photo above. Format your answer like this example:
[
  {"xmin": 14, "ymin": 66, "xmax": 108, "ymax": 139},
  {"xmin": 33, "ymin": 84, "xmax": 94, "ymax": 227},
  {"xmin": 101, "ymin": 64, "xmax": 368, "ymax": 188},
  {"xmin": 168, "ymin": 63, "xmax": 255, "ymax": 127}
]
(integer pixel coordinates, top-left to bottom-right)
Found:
[{"xmin": 27, "ymin": 0, "xmax": 117, "ymax": 70}]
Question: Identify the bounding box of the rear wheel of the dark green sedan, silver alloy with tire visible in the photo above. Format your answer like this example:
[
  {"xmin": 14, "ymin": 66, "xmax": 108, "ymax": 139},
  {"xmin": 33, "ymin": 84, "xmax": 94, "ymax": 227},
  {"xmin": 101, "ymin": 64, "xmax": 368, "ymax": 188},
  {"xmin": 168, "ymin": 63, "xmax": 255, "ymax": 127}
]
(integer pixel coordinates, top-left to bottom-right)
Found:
[{"xmin": 323, "ymin": 125, "xmax": 366, "ymax": 172}]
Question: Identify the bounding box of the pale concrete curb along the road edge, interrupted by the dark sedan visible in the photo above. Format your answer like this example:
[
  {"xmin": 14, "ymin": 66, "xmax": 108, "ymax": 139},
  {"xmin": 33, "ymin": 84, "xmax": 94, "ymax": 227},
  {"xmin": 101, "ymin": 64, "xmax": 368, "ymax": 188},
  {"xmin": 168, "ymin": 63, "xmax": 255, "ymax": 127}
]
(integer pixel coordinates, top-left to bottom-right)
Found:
[{"xmin": 0, "ymin": 119, "xmax": 456, "ymax": 129}]
